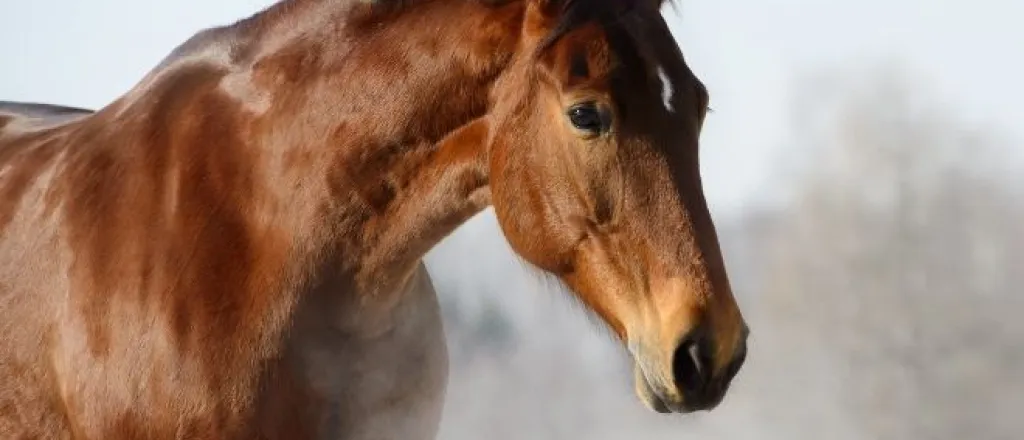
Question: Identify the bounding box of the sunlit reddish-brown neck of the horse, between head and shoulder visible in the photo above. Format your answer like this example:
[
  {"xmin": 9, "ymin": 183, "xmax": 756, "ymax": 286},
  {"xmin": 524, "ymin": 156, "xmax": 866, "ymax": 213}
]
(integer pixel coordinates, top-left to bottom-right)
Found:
[{"xmin": 154, "ymin": 0, "xmax": 521, "ymax": 292}]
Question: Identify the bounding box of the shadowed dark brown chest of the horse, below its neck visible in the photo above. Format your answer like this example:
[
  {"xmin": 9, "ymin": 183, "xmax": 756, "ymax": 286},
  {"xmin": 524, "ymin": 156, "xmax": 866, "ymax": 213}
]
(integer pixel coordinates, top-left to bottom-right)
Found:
[{"xmin": 268, "ymin": 267, "xmax": 447, "ymax": 440}]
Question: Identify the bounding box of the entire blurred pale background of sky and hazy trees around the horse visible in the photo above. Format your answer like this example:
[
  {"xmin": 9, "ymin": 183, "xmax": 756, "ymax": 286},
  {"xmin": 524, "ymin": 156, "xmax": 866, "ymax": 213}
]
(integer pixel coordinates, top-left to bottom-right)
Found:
[{"xmin": 0, "ymin": 0, "xmax": 1024, "ymax": 440}]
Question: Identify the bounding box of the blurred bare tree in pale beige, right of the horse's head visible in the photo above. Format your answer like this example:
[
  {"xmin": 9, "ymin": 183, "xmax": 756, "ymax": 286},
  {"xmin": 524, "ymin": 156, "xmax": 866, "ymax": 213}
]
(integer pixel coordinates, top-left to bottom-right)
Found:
[{"xmin": 759, "ymin": 64, "xmax": 1024, "ymax": 439}]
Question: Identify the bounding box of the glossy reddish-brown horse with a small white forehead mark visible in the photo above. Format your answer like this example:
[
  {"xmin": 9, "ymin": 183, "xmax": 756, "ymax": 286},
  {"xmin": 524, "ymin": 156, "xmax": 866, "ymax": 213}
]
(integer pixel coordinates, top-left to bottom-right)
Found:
[{"xmin": 0, "ymin": 0, "xmax": 748, "ymax": 440}]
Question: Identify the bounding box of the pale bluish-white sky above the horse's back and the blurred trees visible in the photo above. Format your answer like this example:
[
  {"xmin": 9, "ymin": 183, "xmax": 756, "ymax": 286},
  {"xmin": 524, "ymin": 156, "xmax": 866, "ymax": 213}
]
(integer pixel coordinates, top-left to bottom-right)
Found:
[{"xmin": 0, "ymin": 0, "xmax": 1024, "ymax": 211}]
